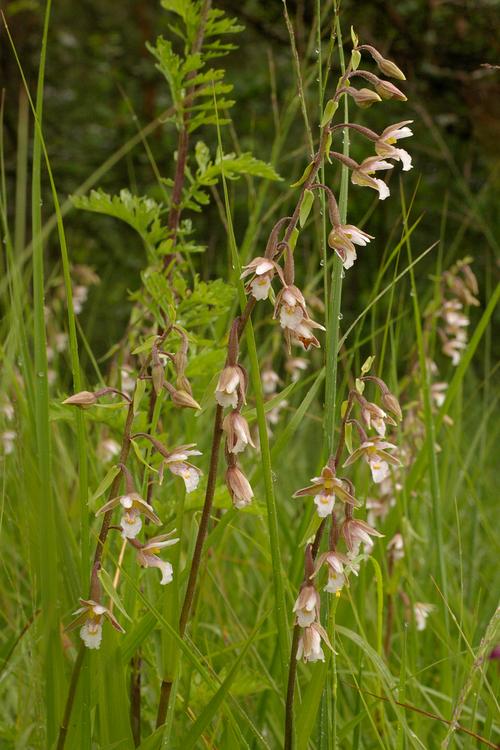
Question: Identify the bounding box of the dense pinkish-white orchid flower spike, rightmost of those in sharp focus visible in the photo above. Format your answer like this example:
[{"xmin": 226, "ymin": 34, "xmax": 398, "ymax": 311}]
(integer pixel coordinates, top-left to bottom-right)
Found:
[{"xmin": 294, "ymin": 366, "xmax": 402, "ymax": 661}]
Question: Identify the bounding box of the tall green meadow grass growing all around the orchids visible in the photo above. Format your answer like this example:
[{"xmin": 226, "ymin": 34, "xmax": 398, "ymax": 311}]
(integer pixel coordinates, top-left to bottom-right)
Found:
[{"xmin": 0, "ymin": 2, "xmax": 500, "ymax": 750}]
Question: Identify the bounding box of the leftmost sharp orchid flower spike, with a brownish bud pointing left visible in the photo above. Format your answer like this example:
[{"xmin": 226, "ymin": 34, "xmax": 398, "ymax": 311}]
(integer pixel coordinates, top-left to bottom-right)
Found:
[{"xmin": 63, "ymin": 325, "xmax": 202, "ymax": 649}]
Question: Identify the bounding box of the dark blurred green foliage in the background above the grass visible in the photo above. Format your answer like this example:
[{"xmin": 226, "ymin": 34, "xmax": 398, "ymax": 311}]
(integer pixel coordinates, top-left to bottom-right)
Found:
[{"xmin": 1, "ymin": 0, "xmax": 500, "ymax": 353}]
